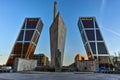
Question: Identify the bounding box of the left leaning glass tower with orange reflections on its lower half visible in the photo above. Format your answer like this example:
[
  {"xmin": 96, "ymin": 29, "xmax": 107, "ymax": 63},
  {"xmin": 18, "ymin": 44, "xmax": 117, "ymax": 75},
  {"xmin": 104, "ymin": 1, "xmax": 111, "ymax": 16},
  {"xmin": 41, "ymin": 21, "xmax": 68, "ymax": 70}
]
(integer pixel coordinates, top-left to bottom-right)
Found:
[{"xmin": 6, "ymin": 18, "xmax": 43, "ymax": 66}]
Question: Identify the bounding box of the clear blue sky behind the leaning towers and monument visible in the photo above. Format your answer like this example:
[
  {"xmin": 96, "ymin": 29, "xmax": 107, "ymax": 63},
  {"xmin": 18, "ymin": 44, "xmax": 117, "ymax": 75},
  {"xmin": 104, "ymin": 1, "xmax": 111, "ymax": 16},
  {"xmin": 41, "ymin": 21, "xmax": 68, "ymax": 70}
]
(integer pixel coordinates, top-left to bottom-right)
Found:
[{"xmin": 0, "ymin": 0, "xmax": 120, "ymax": 65}]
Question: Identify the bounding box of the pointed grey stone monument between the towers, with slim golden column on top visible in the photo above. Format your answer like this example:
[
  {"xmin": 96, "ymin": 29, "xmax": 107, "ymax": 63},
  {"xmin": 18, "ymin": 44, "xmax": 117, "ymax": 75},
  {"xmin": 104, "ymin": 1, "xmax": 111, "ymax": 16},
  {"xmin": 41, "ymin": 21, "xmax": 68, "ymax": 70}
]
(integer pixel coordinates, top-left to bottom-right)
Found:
[{"xmin": 50, "ymin": 2, "xmax": 66, "ymax": 71}]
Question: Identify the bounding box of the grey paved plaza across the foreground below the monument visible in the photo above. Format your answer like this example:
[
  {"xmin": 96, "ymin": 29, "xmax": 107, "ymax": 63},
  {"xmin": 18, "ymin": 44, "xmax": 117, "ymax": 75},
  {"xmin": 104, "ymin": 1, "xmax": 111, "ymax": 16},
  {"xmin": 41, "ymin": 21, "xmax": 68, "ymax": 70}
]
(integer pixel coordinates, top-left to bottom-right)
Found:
[{"xmin": 0, "ymin": 72, "xmax": 120, "ymax": 80}]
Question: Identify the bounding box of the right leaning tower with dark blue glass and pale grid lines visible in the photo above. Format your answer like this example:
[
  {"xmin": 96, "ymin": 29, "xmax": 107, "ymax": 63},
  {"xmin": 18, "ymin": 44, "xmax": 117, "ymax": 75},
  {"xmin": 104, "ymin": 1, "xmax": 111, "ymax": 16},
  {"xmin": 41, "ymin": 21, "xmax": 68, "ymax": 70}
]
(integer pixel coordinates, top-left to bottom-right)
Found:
[{"xmin": 78, "ymin": 17, "xmax": 112, "ymax": 66}]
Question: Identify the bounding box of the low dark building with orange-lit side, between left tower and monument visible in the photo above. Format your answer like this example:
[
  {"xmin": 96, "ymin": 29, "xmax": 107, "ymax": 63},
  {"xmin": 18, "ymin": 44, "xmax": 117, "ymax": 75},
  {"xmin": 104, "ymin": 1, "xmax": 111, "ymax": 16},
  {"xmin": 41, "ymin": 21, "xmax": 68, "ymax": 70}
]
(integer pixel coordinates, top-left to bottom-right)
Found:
[{"xmin": 33, "ymin": 54, "xmax": 49, "ymax": 67}]
